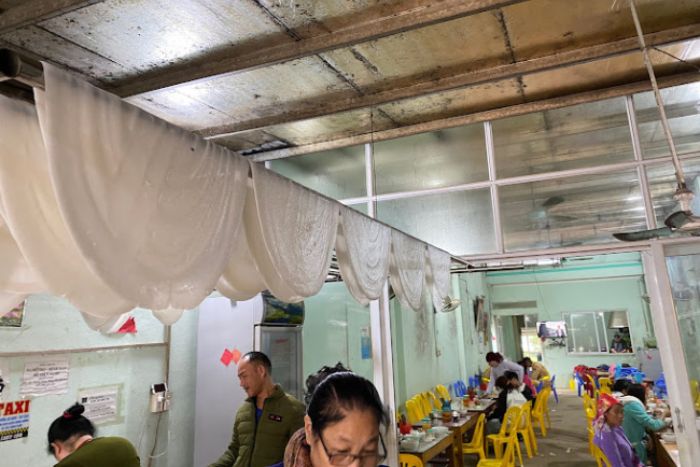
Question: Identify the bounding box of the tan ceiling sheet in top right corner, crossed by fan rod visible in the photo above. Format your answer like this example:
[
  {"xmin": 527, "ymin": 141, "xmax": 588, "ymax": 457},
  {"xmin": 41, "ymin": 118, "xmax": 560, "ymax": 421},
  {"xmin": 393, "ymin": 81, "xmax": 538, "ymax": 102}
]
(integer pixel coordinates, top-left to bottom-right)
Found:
[{"xmin": 503, "ymin": 0, "xmax": 700, "ymax": 60}]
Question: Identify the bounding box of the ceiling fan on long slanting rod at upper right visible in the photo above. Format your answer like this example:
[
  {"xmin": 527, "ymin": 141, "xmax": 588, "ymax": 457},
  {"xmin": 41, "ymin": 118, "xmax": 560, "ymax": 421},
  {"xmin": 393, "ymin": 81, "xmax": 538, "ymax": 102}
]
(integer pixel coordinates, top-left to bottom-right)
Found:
[{"xmin": 613, "ymin": 0, "xmax": 700, "ymax": 242}]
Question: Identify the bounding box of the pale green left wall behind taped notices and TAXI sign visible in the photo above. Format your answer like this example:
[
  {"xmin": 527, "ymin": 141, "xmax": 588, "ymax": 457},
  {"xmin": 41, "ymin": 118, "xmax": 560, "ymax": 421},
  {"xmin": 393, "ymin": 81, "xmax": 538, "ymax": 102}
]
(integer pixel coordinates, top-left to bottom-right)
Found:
[{"xmin": 0, "ymin": 295, "xmax": 198, "ymax": 467}]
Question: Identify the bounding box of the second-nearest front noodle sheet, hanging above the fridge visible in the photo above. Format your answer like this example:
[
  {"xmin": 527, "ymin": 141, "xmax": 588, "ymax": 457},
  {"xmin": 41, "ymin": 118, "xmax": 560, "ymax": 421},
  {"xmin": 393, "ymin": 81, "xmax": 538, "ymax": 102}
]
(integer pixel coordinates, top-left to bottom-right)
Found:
[{"xmin": 245, "ymin": 163, "xmax": 339, "ymax": 302}]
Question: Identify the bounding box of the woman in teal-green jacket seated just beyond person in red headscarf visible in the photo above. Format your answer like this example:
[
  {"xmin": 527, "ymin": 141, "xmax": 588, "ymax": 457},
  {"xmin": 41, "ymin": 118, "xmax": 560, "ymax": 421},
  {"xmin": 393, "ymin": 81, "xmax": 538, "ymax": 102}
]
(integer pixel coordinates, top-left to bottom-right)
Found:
[{"xmin": 622, "ymin": 384, "xmax": 668, "ymax": 464}]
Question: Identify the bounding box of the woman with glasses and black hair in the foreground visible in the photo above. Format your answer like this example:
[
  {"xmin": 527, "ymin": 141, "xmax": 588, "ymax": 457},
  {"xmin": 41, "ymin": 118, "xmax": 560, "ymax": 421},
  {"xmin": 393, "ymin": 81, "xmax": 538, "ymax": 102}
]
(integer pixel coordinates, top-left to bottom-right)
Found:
[{"xmin": 284, "ymin": 372, "xmax": 388, "ymax": 467}]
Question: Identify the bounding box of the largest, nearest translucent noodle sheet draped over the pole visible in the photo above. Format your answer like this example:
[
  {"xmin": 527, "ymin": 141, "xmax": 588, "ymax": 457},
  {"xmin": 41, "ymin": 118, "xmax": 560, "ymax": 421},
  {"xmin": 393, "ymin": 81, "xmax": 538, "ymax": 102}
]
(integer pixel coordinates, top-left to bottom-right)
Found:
[{"xmin": 39, "ymin": 63, "xmax": 248, "ymax": 315}]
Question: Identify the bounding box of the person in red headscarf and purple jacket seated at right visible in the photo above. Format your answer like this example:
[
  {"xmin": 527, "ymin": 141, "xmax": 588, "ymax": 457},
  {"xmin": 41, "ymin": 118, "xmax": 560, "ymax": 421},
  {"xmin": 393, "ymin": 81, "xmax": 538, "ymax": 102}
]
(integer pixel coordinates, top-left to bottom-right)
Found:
[{"xmin": 593, "ymin": 394, "xmax": 644, "ymax": 467}]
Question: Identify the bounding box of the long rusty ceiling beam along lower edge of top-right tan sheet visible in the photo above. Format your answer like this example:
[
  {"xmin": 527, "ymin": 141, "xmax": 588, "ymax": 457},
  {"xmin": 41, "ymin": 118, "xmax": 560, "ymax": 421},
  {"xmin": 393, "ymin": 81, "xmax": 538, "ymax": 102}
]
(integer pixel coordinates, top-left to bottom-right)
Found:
[{"xmin": 202, "ymin": 23, "xmax": 700, "ymax": 138}]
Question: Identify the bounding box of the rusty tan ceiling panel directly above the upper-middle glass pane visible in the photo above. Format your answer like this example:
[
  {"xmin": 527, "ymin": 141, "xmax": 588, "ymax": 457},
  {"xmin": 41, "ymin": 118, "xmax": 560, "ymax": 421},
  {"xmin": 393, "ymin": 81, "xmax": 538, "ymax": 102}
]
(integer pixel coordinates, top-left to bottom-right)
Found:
[{"xmin": 381, "ymin": 79, "xmax": 523, "ymax": 125}]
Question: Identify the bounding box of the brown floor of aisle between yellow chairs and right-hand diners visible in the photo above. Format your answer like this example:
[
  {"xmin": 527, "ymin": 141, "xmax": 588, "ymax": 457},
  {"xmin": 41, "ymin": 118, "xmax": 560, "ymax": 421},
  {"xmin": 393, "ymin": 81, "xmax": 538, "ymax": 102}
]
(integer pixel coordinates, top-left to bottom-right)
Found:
[{"xmin": 464, "ymin": 390, "xmax": 596, "ymax": 467}]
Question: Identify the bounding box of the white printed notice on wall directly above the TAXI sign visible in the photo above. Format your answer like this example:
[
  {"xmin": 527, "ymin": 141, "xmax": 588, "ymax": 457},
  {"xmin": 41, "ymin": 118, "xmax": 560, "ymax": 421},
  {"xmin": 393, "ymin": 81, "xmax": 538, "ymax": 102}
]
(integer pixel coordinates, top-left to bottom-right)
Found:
[{"xmin": 19, "ymin": 357, "xmax": 69, "ymax": 397}]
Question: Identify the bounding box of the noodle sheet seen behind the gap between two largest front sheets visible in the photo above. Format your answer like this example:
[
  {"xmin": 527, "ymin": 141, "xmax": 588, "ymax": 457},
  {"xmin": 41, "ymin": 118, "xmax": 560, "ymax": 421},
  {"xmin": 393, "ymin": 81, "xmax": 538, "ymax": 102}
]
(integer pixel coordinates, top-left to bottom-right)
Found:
[{"xmin": 216, "ymin": 186, "xmax": 267, "ymax": 300}]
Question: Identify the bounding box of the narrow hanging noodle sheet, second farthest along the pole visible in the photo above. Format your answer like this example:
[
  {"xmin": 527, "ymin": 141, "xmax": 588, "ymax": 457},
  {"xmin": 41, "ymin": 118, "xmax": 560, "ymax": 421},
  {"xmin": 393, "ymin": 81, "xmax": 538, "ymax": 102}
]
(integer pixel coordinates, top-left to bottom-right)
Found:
[{"xmin": 389, "ymin": 230, "xmax": 425, "ymax": 311}]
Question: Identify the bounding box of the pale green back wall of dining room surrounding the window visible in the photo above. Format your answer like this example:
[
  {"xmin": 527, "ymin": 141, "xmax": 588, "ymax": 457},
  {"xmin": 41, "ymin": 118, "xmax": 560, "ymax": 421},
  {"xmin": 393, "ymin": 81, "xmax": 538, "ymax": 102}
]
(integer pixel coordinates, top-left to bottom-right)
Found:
[{"xmin": 486, "ymin": 254, "xmax": 652, "ymax": 386}]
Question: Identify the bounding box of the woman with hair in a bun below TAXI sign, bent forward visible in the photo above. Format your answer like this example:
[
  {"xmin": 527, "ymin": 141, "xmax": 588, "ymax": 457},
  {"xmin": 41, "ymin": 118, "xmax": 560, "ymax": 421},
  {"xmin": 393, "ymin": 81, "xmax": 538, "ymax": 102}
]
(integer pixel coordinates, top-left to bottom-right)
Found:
[{"xmin": 48, "ymin": 403, "xmax": 141, "ymax": 467}]
